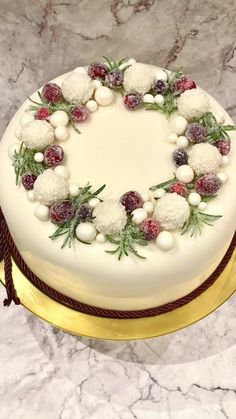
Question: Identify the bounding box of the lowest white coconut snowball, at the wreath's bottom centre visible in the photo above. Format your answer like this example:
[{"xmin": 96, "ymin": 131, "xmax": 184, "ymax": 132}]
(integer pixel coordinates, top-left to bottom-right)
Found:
[{"xmin": 93, "ymin": 199, "xmax": 127, "ymax": 234}]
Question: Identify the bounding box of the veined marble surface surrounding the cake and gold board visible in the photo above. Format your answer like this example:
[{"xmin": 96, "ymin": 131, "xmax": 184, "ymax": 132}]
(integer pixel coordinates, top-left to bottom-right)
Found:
[{"xmin": 0, "ymin": 0, "xmax": 236, "ymax": 419}]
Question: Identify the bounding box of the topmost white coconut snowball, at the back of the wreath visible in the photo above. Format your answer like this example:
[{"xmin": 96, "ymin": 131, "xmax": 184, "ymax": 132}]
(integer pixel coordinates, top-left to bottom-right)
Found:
[{"xmin": 123, "ymin": 63, "xmax": 155, "ymax": 95}]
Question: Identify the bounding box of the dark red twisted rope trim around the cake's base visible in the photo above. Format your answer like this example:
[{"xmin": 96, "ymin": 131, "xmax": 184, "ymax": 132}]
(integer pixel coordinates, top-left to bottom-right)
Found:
[{"xmin": 0, "ymin": 208, "xmax": 236, "ymax": 319}]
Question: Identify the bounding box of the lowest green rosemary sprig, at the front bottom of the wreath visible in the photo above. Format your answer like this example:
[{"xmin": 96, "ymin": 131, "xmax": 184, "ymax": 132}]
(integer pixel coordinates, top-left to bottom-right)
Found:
[{"xmin": 106, "ymin": 217, "xmax": 148, "ymax": 260}]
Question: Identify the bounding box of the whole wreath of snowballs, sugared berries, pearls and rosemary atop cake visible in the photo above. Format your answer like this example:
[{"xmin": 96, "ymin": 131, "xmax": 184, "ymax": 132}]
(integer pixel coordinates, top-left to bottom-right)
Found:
[{"xmin": 8, "ymin": 57, "xmax": 236, "ymax": 260}]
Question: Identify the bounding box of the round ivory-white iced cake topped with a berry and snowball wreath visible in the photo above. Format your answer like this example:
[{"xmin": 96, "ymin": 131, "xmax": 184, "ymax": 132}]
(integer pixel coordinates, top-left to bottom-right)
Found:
[{"xmin": 0, "ymin": 58, "xmax": 236, "ymax": 311}]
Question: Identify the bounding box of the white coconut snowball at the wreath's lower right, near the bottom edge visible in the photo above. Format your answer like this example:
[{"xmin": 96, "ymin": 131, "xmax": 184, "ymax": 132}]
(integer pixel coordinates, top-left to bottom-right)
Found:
[{"xmin": 154, "ymin": 193, "xmax": 190, "ymax": 230}]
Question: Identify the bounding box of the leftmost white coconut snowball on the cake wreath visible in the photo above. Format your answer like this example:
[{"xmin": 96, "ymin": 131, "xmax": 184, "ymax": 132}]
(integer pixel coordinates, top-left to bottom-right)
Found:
[{"xmin": 20, "ymin": 119, "xmax": 54, "ymax": 150}]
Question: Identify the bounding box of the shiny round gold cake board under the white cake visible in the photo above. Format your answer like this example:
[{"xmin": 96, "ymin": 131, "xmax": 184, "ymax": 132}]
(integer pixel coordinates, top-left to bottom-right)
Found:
[{"xmin": 0, "ymin": 251, "xmax": 236, "ymax": 340}]
